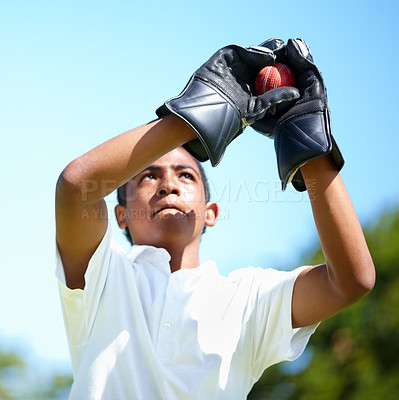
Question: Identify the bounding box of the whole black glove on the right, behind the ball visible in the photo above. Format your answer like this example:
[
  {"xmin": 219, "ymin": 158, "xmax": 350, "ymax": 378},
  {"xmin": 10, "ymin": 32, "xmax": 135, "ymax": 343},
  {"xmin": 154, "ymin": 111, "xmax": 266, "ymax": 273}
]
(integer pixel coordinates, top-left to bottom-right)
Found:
[{"xmin": 253, "ymin": 39, "xmax": 344, "ymax": 191}]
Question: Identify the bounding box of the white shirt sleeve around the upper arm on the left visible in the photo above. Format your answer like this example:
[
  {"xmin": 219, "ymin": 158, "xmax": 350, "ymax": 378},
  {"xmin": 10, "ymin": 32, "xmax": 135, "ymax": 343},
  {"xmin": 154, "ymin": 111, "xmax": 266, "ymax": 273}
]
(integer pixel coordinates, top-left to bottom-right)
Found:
[{"xmin": 55, "ymin": 224, "xmax": 111, "ymax": 352}]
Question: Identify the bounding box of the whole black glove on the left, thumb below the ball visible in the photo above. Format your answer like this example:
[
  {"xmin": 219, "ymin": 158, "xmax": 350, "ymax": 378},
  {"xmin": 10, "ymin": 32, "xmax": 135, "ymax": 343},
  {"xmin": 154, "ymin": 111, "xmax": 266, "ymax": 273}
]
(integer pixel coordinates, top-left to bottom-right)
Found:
[{"xmin": 156, "ymin": 45, "xmax": 299, "ymax": 166}]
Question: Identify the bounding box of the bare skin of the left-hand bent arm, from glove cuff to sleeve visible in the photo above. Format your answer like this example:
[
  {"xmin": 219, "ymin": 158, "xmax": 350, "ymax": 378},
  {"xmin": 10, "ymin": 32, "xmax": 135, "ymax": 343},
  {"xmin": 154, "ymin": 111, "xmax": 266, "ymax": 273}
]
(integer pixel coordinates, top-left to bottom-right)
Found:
[{"xmin": 56, "ymin": 115, "xmax": 196, "ymax": 289}]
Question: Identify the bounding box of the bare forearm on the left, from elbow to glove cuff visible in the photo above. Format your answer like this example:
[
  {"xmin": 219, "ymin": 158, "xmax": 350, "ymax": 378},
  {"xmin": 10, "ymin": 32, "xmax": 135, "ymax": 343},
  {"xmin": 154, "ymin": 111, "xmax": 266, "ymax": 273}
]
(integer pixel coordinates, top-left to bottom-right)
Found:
[{"xmin": 57, "ymin": 115, "xmax": 196, "ymax": 203}]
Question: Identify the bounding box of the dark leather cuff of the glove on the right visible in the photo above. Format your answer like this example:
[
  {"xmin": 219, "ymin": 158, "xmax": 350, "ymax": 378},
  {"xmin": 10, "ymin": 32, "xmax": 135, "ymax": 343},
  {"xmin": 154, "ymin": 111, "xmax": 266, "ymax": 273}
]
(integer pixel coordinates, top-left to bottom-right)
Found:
[{"xmin": 274, "ymin": 108, "xmax": 344, "ymax": 191}]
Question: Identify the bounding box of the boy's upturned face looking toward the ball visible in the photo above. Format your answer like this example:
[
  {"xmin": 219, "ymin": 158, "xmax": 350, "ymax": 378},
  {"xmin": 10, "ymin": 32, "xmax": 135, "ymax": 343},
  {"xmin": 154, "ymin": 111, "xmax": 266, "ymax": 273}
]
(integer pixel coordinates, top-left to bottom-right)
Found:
[{"xmin": 120, "ymin": 148, "xmax": 217, "ymax": 247}]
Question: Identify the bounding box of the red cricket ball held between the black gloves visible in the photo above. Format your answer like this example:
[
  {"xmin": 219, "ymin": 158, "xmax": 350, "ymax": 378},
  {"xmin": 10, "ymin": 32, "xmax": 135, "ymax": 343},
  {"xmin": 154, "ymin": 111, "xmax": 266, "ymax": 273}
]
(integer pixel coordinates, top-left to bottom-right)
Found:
[{"xmin": 255, "ymin": 63, "xmax": 296, "ymax": 95}]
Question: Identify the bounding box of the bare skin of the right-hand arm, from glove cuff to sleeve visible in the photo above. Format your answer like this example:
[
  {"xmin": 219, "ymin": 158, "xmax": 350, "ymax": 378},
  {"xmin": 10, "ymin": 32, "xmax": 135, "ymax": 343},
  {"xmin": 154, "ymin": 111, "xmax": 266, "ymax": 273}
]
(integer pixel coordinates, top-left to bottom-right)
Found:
[{"xmin": 292, "ymin": 156, "xmax": 375, "ymax": 327}]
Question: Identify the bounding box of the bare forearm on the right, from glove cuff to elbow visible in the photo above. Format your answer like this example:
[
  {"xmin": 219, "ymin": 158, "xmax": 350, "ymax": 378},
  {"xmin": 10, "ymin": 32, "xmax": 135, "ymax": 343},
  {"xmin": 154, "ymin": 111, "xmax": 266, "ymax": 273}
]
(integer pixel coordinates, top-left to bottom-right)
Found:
[{"xmin": 301, "ymin": 156, "xmax": 375, "ymax": 300}]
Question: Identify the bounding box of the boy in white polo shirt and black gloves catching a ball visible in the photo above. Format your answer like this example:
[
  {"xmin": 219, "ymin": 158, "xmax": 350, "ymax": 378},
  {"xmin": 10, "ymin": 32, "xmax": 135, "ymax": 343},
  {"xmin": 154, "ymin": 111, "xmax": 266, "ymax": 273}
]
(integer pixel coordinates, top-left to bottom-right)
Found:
[{"xmin": 56, "ymin": 39, "xmax": 374, "ymax": 400}]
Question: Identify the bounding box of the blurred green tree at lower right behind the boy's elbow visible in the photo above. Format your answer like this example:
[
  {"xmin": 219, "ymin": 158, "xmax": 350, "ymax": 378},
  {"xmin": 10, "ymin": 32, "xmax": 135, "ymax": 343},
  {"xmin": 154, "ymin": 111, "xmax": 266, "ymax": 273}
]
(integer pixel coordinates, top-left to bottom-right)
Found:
[{"xmin": 248, "ymin": 209, "xmax": 399, "ymax": 400}]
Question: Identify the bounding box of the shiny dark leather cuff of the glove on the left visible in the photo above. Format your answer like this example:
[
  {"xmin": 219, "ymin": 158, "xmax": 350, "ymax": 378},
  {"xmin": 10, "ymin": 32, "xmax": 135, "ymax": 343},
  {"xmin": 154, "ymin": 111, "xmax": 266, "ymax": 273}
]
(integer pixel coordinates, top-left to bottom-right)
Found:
[{"xmin": 156, "ymin": 76, "xmax": 242, "ymax": 166}]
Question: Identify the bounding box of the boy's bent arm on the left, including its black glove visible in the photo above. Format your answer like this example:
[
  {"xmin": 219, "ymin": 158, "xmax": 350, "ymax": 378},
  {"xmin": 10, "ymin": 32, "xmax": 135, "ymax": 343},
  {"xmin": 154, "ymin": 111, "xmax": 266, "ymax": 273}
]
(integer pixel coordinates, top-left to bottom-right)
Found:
[{"xmin": 56, "ymin": 45, "xmax": 299, "ymax": 288}]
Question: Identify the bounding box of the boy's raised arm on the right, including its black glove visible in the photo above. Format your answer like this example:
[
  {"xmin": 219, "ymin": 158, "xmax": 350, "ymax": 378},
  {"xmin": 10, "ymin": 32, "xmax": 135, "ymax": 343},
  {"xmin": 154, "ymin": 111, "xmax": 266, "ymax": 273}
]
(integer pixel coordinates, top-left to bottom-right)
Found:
[{"xmin": 253, "ymin": 39, "xmax": 375, "ymax": 327}]
